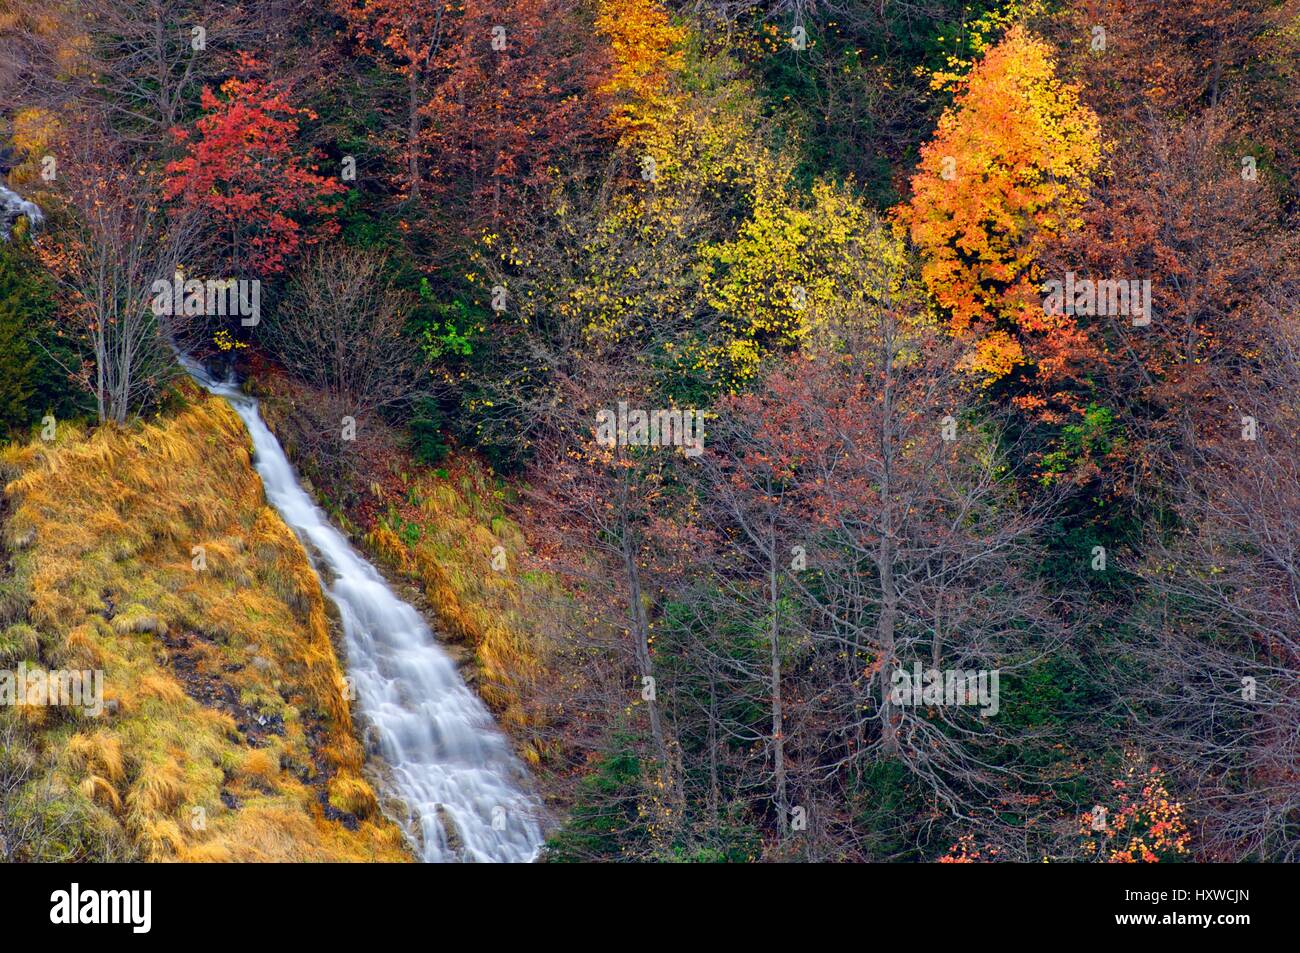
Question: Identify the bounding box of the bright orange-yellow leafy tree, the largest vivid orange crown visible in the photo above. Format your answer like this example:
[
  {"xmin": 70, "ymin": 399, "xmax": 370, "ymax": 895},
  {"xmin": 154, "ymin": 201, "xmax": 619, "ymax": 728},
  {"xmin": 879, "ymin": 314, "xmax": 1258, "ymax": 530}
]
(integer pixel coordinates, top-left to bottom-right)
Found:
[{"xmin": 896, "ymin": 26, "xmax": 1101, "ymax": 382}]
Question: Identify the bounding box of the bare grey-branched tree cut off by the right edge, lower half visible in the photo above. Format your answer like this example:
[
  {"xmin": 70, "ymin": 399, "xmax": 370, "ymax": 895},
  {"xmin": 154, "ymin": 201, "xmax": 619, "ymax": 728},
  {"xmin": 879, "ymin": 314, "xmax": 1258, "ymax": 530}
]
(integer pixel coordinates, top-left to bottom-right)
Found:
[{"xmin": 1114, "ymin": 314, "xmax": 1300, "ymax": 861}]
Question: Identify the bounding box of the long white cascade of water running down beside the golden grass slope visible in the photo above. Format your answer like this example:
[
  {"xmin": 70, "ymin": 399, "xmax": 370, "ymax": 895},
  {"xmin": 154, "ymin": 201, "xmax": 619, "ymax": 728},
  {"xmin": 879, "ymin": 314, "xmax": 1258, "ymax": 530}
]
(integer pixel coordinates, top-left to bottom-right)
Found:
[{"xmin": 181, "ymin": 356, "xmax": 542, "ymax": 862}]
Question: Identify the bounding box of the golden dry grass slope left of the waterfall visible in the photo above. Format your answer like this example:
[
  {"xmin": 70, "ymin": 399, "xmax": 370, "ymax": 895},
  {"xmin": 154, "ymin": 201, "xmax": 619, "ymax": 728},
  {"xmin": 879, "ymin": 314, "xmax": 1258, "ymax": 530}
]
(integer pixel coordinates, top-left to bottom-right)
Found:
[{"xmin": 0, "ymin": 389, "xmax": 408, "ymax": 861}]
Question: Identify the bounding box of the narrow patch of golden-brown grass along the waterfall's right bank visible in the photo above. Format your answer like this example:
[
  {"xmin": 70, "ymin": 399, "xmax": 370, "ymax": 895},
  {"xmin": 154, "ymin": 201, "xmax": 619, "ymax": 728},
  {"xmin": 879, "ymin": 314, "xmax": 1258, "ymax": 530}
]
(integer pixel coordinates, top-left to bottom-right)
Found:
[{"xmin": 255, "ymin": 367, "xmax": 572, "ymax": 764}]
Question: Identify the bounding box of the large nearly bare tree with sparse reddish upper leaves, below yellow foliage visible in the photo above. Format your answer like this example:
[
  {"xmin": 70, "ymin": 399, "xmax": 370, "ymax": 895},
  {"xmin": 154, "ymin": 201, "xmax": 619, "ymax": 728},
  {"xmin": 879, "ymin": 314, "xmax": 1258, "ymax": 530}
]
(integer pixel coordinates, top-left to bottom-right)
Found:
[{"xmin": 681, "ymin": 250, "xmax": 1060, "ymax": 855}]
